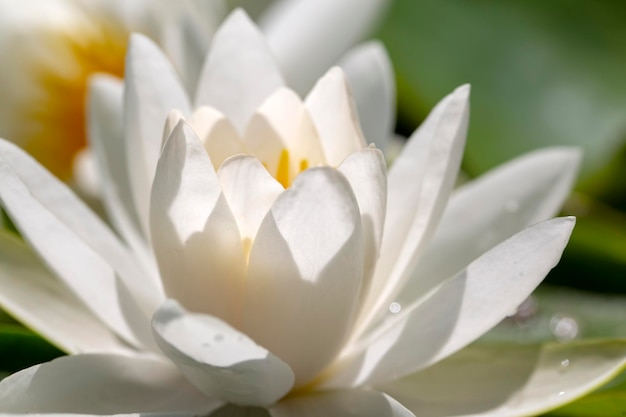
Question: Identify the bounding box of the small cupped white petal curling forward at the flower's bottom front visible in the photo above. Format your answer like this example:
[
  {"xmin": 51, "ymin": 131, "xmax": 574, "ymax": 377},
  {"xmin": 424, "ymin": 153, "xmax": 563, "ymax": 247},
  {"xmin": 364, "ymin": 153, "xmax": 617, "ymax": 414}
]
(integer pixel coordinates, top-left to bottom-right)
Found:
[{"xmin": 152, "ymin": 300, "xmax": 294, "ymax": 406}]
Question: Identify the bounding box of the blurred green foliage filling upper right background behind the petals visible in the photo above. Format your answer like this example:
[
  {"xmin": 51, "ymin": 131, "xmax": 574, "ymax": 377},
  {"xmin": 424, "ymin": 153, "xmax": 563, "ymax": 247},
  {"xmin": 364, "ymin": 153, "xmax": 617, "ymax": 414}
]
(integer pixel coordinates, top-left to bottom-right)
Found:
[{"xmin": 379, "ymin": 0, "xmax": 626, "ymax": 293}]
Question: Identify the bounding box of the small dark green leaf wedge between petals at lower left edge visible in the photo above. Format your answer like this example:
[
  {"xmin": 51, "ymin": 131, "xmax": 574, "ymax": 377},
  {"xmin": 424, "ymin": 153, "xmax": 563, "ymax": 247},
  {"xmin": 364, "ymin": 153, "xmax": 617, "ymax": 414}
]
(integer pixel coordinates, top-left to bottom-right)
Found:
[{"xmin": 0, "ymin": 324, "xmax": 64, "ymax": 377}]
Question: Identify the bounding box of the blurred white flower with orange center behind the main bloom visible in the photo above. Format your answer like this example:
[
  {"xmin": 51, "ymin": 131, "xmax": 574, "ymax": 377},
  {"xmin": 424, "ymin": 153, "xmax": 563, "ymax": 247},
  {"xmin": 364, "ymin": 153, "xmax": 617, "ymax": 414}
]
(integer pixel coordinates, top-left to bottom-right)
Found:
[{"xmin": 0, "ymin": 0, "xmax": 388, "ymax": 184}]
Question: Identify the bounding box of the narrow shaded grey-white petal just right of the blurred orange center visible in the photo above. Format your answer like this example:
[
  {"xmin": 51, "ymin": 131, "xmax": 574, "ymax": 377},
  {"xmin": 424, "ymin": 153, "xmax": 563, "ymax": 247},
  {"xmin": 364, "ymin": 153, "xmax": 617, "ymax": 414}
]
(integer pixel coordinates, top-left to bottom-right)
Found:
[{"xmin": 87, "ymin": 74, "xmax": 160, "ymax": 276}]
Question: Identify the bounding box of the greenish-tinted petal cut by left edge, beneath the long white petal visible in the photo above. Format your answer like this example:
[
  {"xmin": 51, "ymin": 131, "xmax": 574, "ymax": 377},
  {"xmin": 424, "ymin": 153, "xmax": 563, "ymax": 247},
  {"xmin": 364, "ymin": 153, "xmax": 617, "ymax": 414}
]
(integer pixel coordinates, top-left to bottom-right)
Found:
[{"xmin": 0, "ymin": 231, "xmax": 131, "ymax": 353}]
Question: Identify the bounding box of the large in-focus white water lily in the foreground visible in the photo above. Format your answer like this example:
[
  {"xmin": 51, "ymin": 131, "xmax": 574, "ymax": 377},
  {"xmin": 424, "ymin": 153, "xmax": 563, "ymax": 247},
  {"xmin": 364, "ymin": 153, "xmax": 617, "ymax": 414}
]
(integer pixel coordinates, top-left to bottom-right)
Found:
[{"xmin": 0, "ymin": 8, "xmax": 626, "ymax": 417}]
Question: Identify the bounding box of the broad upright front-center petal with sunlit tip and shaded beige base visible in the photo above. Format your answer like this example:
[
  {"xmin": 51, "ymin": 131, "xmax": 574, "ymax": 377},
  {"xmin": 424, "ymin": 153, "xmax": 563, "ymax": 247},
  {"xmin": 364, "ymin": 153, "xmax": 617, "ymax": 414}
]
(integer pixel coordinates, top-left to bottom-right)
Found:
[{"xmin": 243, "ymin": 168, "xmax": 363, "ymax": 384}]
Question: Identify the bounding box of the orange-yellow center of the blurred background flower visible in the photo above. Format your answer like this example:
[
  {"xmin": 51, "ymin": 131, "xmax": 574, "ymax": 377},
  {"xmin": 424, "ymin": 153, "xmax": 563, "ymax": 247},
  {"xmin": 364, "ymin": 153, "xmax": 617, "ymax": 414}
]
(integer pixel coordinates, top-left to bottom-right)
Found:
[{"xmin": 17, "ymin": 22, "xmax": 128, "ymax": 180}]
